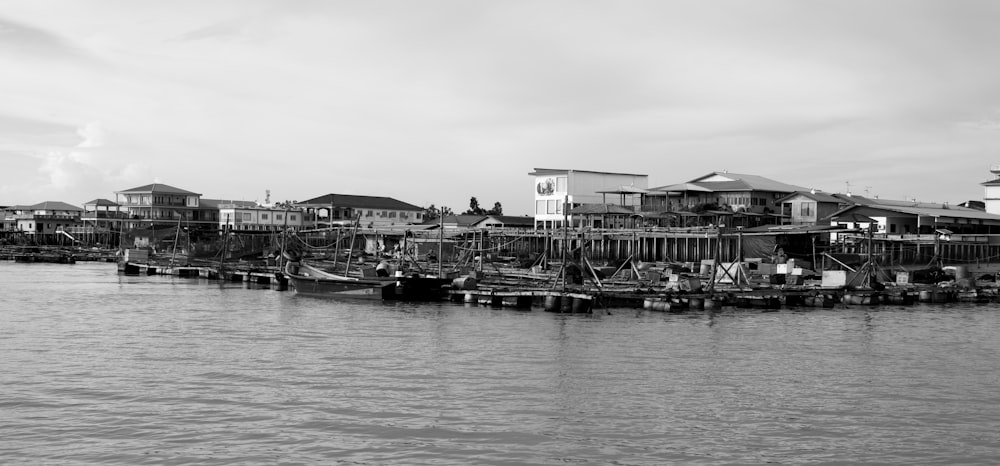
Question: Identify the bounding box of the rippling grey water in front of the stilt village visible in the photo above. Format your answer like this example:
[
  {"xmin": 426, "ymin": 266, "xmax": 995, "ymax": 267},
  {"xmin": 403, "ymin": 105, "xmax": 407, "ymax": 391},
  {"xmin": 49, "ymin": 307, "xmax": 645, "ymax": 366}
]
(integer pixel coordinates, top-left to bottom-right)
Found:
[{"xmin": 0, "ymin": 262, "xmax": 1000, "ymax": 465}]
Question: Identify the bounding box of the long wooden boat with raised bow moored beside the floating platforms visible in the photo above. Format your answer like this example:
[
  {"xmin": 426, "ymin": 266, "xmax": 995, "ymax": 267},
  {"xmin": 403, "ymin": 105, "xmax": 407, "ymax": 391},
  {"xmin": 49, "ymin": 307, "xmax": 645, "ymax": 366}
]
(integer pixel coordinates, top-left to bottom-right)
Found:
[{"xmin": 285, "ymin": 261, "xmax": 451, "ymax": 301}]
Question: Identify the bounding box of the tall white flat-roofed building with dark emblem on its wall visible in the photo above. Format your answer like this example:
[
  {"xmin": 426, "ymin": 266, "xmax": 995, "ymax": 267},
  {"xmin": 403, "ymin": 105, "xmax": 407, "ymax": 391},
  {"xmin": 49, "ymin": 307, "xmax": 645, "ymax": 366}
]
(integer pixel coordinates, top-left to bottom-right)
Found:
[{"xmin": 528, "ymin": 168, "xmax": 649, "ymax": 229}]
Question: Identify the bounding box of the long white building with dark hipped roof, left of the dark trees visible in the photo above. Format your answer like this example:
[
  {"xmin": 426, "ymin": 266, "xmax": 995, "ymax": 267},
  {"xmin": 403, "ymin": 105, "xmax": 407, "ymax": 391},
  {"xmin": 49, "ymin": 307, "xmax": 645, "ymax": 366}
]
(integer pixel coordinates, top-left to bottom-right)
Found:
[{"xmin": 295, "ymin": 194, "xmax": 424, "ymax": 228}]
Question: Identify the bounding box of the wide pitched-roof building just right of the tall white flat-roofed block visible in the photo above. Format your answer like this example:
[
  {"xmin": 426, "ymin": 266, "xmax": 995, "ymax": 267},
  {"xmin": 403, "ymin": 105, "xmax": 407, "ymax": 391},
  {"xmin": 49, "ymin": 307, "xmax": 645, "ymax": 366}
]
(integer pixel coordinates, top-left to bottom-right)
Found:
[{"xmin": 645, "ymin": 172, "xmax": 809, "ymax": 214}]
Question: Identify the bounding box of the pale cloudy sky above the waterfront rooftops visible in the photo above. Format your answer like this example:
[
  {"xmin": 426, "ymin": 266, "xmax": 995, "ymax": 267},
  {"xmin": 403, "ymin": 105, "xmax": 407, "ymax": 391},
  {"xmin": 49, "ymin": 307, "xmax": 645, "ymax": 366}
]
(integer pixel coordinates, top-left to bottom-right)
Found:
[{"xmin": 0, "ymin": 0, "xmax": 1000, "ymax": 215}]
